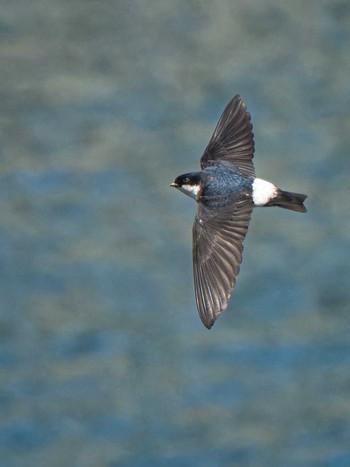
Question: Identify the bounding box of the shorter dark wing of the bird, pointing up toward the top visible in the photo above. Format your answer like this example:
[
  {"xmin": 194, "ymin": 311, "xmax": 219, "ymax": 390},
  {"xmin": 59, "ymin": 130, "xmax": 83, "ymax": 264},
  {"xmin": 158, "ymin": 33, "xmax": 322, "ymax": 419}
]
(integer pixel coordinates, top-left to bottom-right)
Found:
[{"xmin": 200, "ymin": 95, "xmax": 255, "ymax": 177}]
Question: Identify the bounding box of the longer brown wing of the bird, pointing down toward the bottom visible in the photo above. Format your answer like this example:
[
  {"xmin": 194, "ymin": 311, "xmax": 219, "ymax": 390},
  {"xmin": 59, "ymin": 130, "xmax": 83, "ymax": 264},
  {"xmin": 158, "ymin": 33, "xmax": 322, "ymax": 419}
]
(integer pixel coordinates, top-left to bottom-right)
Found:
[{"xmin": 193, "ymin": 195, "xmax": 253, "ymax": 329}]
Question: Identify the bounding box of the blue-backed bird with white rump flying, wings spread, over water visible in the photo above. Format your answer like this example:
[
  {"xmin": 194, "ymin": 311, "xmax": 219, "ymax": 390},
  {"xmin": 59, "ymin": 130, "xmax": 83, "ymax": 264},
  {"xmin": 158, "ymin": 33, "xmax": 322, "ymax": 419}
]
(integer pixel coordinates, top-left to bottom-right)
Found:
[{"xmin": 170, "ymin": 95, "xmax": 307, "ymax": 329}]
